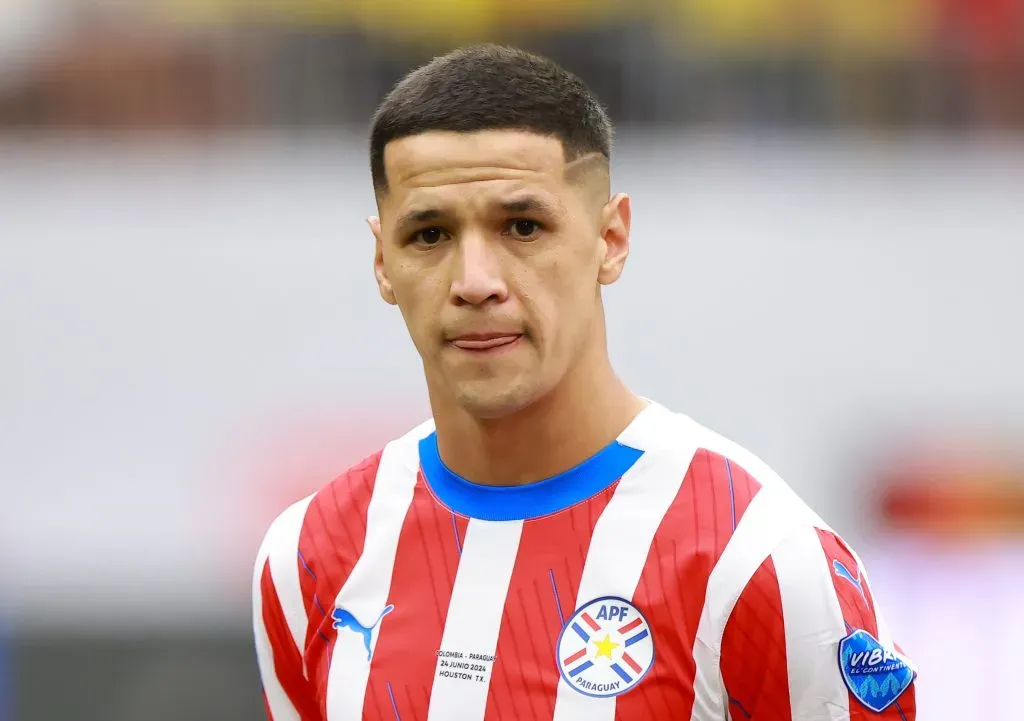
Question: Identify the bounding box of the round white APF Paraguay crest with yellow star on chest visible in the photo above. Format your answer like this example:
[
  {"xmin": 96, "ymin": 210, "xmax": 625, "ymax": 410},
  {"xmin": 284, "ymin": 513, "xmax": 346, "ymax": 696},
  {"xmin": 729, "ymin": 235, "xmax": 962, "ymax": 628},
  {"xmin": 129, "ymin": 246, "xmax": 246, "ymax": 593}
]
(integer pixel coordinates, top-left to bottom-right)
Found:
[{"xmin": 557, "ymin": 596, "xmax": 654, "ymax": 698}]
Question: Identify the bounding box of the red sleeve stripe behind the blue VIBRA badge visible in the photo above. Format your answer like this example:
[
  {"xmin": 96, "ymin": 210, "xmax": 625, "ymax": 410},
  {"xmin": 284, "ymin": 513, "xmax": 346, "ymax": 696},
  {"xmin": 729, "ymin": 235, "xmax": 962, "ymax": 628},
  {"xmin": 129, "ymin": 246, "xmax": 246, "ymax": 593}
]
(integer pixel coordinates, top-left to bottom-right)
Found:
[{"xmin": 818, "ymin": 529, "xmax": 916, "ymax": 721}]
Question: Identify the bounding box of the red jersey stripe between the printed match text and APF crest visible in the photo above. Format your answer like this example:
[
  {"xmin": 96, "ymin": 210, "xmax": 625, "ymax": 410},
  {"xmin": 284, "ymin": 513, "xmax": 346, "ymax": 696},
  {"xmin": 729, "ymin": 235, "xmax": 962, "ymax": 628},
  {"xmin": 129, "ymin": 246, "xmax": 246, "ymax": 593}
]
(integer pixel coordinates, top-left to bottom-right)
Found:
[{"xmin": 481, "ymin": 483, "xmax": 617, "ymax": 721}]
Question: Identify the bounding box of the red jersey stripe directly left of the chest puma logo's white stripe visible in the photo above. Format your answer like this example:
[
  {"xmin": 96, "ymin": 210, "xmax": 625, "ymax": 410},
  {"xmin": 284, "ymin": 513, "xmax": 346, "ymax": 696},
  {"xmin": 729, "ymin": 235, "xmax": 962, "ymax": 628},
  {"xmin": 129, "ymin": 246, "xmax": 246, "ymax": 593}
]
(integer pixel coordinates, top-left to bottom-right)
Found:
[{"xmin": 296, "ymin": 452, "xmax": 383, "ymax": 718}]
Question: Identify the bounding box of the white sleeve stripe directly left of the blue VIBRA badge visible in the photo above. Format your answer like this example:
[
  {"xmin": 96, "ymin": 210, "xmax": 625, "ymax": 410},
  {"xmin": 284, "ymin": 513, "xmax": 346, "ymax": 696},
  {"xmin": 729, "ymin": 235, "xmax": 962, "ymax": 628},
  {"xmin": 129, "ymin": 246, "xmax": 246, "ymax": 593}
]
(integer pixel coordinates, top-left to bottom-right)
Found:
[{"xmin": 772, "ymin": 527, "xmax": 850, "ymax": 721}]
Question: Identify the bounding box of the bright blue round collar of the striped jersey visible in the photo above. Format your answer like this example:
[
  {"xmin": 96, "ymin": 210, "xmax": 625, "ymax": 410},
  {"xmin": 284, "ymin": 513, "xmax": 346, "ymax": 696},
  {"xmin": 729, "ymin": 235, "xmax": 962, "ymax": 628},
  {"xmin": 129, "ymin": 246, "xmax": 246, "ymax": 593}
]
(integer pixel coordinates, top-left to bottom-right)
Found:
[{"xmin": 420, "ymin": 433, "xmax": 643, "ymax": 520}]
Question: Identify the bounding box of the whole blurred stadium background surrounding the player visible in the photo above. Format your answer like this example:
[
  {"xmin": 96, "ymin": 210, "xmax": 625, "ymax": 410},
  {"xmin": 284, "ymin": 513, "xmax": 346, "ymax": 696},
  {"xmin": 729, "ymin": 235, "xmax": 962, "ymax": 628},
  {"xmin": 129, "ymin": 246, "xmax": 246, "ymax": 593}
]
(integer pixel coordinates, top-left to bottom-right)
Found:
[{"xmin": 0, "ymin": 0, "xmax": 1024, "ymax": 721}]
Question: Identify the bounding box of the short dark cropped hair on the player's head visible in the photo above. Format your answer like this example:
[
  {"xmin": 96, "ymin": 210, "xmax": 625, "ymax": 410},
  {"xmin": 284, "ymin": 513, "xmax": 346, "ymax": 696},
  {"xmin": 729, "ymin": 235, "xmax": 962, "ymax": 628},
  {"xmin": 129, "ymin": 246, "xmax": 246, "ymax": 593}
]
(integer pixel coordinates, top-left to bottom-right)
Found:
[{"xmin": 370, "ymin": 45, "xmax": 612, "ymax": 190}]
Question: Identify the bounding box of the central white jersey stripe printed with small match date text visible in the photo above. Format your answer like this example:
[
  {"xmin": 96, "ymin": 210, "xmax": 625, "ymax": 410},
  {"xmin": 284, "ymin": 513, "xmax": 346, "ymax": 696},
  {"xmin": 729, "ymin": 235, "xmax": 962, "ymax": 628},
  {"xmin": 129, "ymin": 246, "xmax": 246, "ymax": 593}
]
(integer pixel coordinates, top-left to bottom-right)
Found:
[{"xmin": 427, "ymin": 519, "xmax": 522, "ymax": 721}]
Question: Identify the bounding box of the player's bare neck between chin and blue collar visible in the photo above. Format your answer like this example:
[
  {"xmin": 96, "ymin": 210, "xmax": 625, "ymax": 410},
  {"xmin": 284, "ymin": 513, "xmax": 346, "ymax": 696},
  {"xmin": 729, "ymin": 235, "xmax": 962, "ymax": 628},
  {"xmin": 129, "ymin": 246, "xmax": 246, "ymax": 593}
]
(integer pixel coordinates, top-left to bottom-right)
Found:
[{"xmin": 431, "ymin": 342, "xmax": 645, "ymax": 485}]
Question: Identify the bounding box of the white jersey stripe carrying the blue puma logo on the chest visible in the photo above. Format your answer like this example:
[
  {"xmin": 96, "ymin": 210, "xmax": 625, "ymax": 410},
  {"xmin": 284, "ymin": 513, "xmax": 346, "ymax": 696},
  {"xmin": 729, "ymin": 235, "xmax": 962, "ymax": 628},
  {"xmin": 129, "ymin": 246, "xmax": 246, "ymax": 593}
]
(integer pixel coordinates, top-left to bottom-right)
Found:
[{"xmin": 327, "ymin": 424, "xmax": 430, "ymax": 721}]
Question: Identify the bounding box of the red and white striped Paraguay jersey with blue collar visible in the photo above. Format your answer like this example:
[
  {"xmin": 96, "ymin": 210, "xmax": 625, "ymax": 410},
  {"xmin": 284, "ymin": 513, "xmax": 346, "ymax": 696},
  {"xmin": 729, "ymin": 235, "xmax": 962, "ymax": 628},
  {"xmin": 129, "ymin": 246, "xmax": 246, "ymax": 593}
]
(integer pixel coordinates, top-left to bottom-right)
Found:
[{"xmin": 253, "ymin": 404, "xmax": 916, "ymax": 721}]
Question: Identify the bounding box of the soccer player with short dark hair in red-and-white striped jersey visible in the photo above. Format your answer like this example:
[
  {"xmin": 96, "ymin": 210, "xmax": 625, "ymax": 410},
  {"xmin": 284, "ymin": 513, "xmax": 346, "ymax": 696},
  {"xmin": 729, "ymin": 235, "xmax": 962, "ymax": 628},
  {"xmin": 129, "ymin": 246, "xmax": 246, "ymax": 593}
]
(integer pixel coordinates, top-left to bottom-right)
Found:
[{"xmin": 253, "ymin": 46, "xmax": 915, "ymax": 721}]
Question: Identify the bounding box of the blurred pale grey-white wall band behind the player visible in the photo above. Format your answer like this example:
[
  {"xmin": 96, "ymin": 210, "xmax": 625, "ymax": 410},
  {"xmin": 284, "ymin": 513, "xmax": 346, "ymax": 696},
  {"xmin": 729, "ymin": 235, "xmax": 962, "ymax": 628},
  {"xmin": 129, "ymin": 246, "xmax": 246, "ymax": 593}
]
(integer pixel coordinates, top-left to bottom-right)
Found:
[{"xmin": 0, "ymin": 135, "xmax": 1024, "ymax": 627}]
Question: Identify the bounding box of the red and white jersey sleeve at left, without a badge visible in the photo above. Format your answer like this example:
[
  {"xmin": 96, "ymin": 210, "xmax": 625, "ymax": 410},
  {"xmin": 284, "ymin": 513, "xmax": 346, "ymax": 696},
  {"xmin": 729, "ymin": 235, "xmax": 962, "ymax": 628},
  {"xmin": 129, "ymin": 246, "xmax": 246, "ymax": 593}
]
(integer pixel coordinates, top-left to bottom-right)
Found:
[{"xmin": 252, "ymin": 497, "xmax": 321, "ymax": 721}]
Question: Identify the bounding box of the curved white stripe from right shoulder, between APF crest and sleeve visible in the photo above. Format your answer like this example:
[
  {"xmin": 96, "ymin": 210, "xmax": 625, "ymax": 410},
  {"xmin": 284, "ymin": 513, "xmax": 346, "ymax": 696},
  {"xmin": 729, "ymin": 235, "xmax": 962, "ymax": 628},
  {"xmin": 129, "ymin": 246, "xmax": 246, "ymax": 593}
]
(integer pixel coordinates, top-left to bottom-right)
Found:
[{"xmin": 690, "ymin": 486, "xmax": 809, "ymax": 721}]
